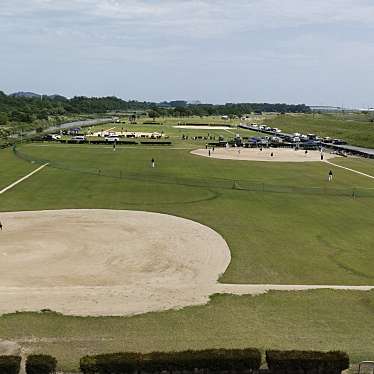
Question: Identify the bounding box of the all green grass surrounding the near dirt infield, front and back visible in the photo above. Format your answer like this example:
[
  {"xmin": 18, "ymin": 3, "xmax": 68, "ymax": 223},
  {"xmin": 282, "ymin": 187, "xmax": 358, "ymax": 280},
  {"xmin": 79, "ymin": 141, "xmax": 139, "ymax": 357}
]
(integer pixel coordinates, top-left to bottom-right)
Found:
[{"xmin": 0, "ymin": 117, "xmax": 374, "ymax": 369}]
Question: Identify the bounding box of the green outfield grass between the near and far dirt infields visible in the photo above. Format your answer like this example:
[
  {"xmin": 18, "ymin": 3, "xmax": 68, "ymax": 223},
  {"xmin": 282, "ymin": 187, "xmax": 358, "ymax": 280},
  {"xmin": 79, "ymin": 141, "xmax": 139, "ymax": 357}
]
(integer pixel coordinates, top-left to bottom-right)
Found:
[{"xmin": 0, "ymin": 145, "xmax": 374, "ymax": 285}]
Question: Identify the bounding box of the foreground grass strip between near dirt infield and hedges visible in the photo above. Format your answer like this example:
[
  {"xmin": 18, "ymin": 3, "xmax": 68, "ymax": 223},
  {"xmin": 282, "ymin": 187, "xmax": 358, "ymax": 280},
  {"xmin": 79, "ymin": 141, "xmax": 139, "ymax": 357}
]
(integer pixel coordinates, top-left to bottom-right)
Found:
[{"xmin": 0, "ymin": 290, "xmax": 374, "ymax": 371}]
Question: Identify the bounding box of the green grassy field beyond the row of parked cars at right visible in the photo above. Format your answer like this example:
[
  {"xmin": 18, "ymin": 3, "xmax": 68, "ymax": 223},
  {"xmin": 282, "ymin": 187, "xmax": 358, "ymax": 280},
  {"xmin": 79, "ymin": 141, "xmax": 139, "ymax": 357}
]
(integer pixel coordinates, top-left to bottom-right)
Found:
[{"xmin": 266, "ymin": 114, "xmax": 374, "ymax": 148}]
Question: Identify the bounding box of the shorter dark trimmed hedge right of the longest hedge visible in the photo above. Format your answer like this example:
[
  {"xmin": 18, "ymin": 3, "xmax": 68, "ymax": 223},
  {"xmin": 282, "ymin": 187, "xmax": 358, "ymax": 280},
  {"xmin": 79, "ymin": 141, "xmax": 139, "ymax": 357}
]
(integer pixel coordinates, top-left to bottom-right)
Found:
[{"xmin": 266, "ymin": 351, "xmax": 349, "ymax": 374}]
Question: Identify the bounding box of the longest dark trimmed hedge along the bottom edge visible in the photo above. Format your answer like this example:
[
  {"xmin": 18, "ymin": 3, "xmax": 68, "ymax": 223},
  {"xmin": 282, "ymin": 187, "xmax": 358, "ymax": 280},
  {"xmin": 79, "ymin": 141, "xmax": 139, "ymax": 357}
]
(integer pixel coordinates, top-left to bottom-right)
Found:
[{"xmin": 80, "ymin": 349, "xmax": 261, "ymax": 374}]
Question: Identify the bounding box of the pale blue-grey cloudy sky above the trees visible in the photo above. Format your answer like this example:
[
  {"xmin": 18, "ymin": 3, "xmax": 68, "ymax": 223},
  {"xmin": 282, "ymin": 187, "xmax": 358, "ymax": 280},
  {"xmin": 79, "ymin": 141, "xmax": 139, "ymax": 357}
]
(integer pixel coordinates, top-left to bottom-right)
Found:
[{"xmin": 0, "ymin": 0, "xmax": 374, "ymax": 108}]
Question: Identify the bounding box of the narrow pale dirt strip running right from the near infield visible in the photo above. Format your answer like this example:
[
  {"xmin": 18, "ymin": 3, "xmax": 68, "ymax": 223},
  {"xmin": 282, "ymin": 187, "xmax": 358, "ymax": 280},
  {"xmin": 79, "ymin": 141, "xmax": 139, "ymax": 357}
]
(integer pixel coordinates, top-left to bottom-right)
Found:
[{"xmin": 216, "ymin": 283, "xmax": 374, "ymax": 295}]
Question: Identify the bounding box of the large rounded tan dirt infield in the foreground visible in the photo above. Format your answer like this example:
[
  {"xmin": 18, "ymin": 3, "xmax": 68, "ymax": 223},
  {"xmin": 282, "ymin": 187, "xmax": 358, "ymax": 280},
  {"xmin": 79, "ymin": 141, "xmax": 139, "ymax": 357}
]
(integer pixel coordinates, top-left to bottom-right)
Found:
[{"xmin": 0, "ymin": 210, "xmax": 231, "ymax": 315}]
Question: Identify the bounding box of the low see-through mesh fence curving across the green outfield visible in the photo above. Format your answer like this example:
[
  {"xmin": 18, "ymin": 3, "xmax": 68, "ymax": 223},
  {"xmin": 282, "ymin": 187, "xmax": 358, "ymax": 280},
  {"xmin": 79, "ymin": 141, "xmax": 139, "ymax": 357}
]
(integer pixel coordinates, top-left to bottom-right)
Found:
[{"xmin": 13, "ymin": 146, "xmax": 374, "ymax": 199}]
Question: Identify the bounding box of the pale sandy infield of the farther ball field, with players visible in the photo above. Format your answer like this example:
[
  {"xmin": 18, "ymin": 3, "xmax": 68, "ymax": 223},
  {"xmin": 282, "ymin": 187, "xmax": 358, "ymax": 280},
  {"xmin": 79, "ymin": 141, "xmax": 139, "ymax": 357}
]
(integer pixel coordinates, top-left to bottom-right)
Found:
[{"xmin": 191, "ymin": 148, "xmax": 338, "ymax": 162}]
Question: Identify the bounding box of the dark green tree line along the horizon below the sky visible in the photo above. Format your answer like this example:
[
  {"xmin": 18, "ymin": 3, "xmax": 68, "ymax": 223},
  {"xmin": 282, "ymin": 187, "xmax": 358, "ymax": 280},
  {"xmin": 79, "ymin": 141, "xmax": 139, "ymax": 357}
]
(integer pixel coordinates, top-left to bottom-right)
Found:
[{"xmin": 0, "ymin": 91, "xmax": 310, "ymax": 126}]
